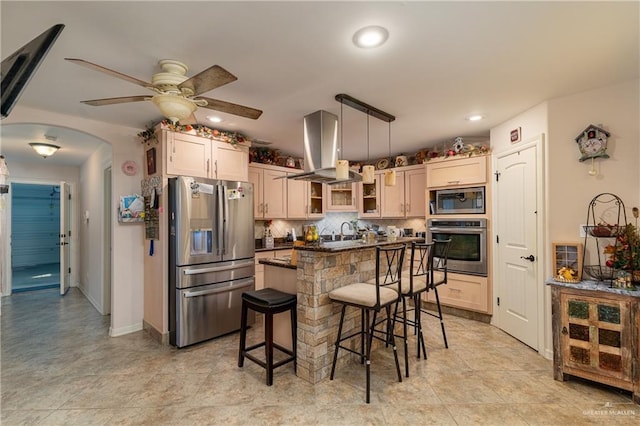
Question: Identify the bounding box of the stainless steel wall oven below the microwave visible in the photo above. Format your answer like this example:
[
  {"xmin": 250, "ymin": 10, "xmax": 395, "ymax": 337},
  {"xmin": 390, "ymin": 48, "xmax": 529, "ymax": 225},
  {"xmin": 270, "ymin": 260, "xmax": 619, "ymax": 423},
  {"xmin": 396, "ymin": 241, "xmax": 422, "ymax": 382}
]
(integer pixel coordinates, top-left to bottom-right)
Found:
[{"xmin": 427, "ymin": 219, "xmax": 487, "ymax": 277}]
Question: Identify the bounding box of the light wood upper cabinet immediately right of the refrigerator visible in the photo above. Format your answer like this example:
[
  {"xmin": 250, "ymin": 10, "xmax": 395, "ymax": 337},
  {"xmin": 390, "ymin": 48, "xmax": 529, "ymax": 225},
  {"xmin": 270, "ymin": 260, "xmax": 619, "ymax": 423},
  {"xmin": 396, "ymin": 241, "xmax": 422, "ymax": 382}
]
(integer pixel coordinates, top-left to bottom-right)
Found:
[{"xmin": 248, "ymin": 164, "xmax": 287, "ymax": 220}]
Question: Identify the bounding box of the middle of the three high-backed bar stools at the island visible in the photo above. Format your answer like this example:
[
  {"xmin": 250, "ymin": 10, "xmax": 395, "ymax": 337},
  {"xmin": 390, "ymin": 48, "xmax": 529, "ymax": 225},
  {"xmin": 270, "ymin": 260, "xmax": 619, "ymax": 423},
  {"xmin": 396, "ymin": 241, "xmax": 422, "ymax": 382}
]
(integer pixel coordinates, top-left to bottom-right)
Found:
[{"xmin": 393, "ymin": 241, "xmax": 433, "ymax": 377}]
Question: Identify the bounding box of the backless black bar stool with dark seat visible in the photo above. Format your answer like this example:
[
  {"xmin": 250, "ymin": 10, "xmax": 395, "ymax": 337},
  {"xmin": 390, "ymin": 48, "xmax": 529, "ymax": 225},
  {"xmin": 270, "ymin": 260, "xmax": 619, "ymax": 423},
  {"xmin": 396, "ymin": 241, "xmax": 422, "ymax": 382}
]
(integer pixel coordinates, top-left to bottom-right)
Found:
[{"xmin": 238, "ymin": 288, "xmax": 297, "ymax": 386}]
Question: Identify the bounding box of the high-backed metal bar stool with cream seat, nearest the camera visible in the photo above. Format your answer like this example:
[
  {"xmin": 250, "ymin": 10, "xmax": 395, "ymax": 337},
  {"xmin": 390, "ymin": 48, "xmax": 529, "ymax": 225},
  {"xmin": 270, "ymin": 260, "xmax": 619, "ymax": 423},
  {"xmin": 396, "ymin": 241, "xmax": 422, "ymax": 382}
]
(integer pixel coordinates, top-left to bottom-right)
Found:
[{"xmin": 329, "ymin": 244, "xmax": 406, "ymax": 404}]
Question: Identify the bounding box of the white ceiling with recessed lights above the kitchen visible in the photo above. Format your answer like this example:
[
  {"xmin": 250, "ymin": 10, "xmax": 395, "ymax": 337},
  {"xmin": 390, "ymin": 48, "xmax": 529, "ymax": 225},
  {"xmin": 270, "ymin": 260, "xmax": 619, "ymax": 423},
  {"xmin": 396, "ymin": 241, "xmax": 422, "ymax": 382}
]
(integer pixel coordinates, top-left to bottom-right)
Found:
[{"xmin": 0, "ymin": 0, "xmax": 640, "ymax": 163}]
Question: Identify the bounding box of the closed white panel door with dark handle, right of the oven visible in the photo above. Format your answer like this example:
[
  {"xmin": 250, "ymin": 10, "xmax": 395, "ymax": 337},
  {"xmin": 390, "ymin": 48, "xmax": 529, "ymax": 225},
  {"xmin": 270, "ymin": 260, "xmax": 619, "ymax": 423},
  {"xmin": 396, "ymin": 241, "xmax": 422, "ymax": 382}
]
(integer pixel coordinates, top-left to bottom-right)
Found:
[{"xmin": 495, "ymin": 145, "xmax": 540, "ymax": 350}]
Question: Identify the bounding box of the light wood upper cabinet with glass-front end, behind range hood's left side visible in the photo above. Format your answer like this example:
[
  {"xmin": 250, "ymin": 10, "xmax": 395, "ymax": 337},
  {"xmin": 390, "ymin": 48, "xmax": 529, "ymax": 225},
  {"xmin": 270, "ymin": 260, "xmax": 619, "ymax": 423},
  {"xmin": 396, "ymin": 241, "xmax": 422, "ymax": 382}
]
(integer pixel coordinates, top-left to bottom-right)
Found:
[{"xmin": 287, "ymin": 180, "xmax": 326, "ymax": 219}]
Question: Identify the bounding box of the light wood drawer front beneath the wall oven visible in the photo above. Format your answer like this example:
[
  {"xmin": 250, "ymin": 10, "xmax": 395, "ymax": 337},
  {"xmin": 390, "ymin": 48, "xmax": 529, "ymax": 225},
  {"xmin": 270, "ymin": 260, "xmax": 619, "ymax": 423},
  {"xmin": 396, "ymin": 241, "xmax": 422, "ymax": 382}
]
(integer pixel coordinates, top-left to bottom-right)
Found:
[{"xmin": 426, "ymin": 272, "xmax": 492, "ymax": 314}]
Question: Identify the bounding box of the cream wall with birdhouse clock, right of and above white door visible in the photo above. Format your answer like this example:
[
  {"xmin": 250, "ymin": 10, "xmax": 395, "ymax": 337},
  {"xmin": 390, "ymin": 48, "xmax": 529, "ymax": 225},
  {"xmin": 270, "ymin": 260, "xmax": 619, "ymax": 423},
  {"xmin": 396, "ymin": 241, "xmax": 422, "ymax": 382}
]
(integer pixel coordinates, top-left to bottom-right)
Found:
[{"xmin": 491, "ymin": 80, "xmax": 640, "ymax": 357}]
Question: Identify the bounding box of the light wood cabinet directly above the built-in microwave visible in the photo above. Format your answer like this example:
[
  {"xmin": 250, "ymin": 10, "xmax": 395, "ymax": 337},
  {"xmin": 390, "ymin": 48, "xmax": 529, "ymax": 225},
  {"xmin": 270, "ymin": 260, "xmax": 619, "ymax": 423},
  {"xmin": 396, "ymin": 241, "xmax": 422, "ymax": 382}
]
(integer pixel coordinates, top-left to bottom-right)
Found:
[{"xmin": 427, "ymin": 155, "xmax": 489, "ymax": 188}]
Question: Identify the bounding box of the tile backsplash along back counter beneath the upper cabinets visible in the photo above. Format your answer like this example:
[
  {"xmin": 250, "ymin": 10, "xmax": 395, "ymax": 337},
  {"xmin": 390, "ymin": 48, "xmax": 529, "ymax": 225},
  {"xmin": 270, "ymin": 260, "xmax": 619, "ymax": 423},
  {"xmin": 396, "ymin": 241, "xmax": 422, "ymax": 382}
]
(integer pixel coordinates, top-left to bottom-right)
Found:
[{"xmin": 254, "ymin": 213, "xmax": 426, "ymax": 238}]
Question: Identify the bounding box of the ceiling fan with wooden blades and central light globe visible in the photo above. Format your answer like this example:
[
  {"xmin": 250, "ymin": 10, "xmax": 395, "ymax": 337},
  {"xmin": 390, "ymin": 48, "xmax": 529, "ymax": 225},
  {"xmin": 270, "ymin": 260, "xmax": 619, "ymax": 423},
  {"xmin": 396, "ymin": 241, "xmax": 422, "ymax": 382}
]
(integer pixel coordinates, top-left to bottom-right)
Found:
[{"xmin": 65, "ymin": 58, "xmax": 262, "ymax": 123}]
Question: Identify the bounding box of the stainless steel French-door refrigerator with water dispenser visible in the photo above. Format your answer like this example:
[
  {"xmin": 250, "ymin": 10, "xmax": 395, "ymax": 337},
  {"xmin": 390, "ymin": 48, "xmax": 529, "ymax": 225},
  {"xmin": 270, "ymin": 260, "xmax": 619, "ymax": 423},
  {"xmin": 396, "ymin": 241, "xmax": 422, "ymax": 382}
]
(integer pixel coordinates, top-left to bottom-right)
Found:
[{"xmin": 168, "ymin": 176, "xmax": 255, "ymax": 347}]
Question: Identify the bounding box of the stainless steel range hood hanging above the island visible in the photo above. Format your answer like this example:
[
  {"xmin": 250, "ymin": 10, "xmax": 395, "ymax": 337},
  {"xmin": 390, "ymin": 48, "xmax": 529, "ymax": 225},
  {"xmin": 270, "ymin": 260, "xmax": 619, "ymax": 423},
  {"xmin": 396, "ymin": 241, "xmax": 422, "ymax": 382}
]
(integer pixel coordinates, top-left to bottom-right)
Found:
[{"xmin": 287, "ymin": 110, "xmax": 362, "ymax": 185}]
